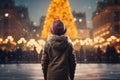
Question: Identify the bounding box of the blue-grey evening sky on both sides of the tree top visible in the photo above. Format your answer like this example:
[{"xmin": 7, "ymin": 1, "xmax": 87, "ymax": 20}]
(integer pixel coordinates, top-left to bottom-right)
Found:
[{"xmin": 15, "ymin": 0, "xmax": 103, "ymax": 28}]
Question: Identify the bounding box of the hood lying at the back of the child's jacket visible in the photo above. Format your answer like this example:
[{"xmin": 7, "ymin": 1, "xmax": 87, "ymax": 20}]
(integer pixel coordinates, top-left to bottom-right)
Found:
[{"xmin": 47, "ymin": 35, "xmax": 68, "ymax": 51}]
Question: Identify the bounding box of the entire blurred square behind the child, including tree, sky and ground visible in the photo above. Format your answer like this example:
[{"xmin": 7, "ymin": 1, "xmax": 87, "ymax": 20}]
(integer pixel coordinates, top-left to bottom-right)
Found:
[{"xmin": 0, "ymin": 0, "xmax": 120, "ymax": 80}]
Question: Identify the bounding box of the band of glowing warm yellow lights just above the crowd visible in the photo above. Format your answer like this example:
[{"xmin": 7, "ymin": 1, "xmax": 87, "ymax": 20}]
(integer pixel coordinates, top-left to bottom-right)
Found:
[{"xmin": 0, "ymin": 36, "xmax": 120, "ymax": 54}]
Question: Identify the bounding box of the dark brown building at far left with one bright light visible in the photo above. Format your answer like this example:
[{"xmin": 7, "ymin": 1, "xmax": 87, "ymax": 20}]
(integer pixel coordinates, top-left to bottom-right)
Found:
[{"xmin": 0, "ymin": 0, "xmax": 29, "ymax": 41}]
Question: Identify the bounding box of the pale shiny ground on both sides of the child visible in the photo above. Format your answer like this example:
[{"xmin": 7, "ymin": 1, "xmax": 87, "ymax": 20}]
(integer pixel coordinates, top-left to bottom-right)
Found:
[{"xmin": 0, "ymin": 64, "xmax": 120, "ymax": 80}]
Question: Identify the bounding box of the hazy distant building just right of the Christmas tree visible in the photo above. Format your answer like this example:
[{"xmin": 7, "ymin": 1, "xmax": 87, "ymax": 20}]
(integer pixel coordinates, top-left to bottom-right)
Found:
[{"xmin": 73, "ymin": 11, "xmax": 90, "ymax": 39}]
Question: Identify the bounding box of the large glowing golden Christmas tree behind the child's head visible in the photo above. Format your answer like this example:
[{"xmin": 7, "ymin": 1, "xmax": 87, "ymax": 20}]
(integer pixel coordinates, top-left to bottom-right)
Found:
[{"xmin": 41, "ymin": 0, "xmax": 78, "ymax": 39}]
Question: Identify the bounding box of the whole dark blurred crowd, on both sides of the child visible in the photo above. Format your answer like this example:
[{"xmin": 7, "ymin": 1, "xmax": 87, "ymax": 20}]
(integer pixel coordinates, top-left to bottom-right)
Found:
[{"xmin": 0, "ymin": 45, "xmax": 120, "ymax": 64}]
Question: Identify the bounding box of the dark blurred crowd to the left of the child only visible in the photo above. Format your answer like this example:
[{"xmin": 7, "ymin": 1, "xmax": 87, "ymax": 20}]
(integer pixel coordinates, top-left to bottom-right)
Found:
[{"xmin": 0, "ymin": 48, "xmax": 40, "ymax": 64}]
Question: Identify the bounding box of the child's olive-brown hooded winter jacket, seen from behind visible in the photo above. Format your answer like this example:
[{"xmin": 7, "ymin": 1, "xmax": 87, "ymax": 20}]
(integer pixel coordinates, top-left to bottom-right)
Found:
[{"xmin": 41, "ymin": 35, "xmax": 76, "ymax": 80}]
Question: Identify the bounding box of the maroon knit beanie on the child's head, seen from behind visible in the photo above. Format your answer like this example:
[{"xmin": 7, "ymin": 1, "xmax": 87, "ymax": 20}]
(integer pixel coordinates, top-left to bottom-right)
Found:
[{"xmin": 51, "ymin": 20, "xmax": 66, "ymax": 36}]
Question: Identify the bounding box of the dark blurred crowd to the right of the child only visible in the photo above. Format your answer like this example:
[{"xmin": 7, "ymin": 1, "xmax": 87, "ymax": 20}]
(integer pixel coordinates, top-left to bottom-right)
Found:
[{"xmin": 76, "ymin": 45, "xmax": 120, "ymax": 63}]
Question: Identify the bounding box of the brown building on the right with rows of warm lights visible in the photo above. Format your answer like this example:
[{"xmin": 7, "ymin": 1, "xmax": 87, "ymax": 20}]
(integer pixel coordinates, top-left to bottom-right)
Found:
[{"xmin": 92, "ymin": 0, "xmax": 120, "ymax": 50}]
